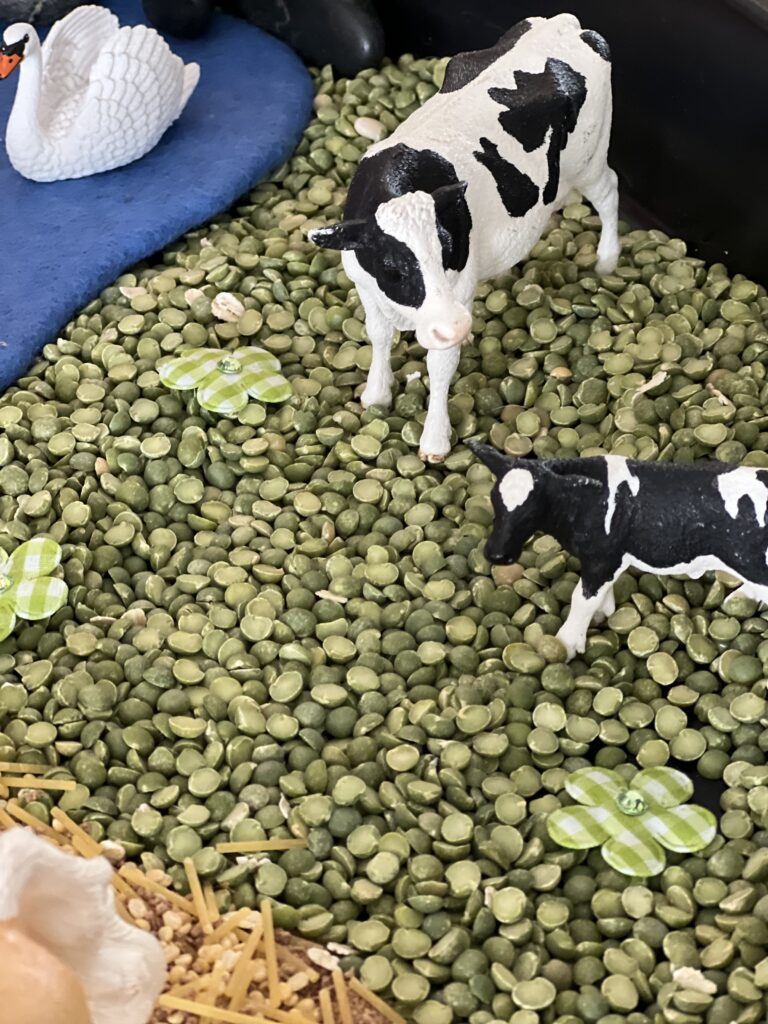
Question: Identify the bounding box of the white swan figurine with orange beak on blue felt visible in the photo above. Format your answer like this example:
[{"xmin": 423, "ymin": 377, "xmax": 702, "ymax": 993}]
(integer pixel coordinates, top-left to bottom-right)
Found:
[{"xmin": 0, "ymin": 5, "xmax": 200, "ymax": 181}]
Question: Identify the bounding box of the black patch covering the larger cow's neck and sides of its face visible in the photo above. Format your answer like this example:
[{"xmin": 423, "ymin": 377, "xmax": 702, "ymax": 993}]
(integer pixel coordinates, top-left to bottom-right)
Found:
[{"xmin": 344, "ymin": 142, "xmax": 472, "ymax": 307}]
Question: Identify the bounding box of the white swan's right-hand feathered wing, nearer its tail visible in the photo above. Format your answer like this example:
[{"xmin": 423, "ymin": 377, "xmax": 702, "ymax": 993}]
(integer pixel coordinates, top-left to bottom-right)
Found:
[{"xmin": 78, "ymin": 25, "xmax": 200, "ymax": 167}]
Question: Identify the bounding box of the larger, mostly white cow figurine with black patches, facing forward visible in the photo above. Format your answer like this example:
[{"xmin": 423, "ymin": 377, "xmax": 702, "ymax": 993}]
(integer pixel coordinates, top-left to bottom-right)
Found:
[{"xmin": 309, "ymin": 14, "xmax": 620, "ymax": 462}]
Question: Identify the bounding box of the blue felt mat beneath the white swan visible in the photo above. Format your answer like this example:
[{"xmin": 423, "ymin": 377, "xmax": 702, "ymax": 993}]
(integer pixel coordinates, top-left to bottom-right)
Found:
[{"xmin": 0, "ymin": 0, "xmax": 312, "ymax": 389}]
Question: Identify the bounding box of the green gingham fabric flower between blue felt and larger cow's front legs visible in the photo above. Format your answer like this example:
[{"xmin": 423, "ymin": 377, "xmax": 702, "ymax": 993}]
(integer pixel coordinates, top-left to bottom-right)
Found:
[{"xmin": 158, "ymin": 348, "xmax": 291, "ymax": 416}]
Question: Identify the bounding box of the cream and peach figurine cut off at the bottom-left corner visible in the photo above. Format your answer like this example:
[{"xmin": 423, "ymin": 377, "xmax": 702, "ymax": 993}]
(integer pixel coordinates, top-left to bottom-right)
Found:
[{"xmin": 0, "ymin": 827, "xmax": 166, "ymax": 1024}]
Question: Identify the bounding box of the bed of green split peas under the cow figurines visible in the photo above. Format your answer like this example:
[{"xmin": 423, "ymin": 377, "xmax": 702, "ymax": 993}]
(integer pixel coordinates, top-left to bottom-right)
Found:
[{"xmin": 0, "ymin": 51, "xmax": 768, "ymax": 1024}]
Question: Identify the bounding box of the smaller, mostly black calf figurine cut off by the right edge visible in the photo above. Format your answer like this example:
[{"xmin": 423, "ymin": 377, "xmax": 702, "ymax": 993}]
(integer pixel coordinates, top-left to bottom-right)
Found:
[{"xmin": 470, "ymin": 442, "xmax": 768, "ymax": 657}]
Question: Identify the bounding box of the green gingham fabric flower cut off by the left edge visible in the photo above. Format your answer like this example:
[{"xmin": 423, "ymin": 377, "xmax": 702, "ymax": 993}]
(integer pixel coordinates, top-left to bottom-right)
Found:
[{"xmin": 0, "ymin": 537, "xmax": 67, "ymax": 640}]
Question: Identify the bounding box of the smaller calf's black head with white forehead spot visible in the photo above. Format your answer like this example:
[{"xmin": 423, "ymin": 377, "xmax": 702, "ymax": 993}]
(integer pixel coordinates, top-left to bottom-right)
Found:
[{"xmin": 468, "ymin": 441, "xmax": 548, "ymax": 565}]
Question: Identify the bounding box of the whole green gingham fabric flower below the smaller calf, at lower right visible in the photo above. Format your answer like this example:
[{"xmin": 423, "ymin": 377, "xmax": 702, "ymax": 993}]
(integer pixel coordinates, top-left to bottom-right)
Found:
[{"xmin": 547, "ymin": 768, "xmax": 717, "ymax": 878}]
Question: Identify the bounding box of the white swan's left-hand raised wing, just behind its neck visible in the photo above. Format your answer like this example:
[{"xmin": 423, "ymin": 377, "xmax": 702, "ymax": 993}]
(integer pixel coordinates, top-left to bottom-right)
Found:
[{"xmin": 39, "ymin": 5, "xmax": 120, "ymax": 131}]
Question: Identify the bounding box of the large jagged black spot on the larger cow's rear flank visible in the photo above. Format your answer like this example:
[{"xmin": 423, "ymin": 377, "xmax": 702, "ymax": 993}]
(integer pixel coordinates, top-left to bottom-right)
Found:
[{"xmin": 488, "ymin": 57, "xmax": 587, "ymax": 203}]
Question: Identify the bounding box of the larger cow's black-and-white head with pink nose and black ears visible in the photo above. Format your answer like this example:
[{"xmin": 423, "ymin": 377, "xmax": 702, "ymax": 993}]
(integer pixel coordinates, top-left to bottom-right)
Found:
[{"xmin": 309, "ymin": 181, "xmax": 472, "ymax": 349}]
